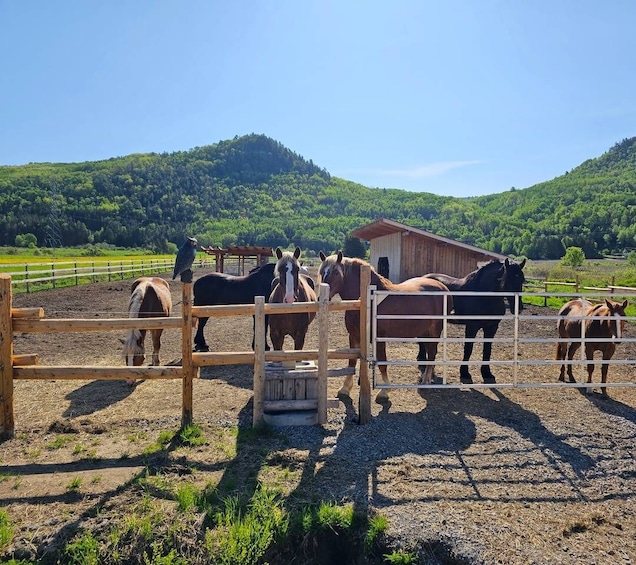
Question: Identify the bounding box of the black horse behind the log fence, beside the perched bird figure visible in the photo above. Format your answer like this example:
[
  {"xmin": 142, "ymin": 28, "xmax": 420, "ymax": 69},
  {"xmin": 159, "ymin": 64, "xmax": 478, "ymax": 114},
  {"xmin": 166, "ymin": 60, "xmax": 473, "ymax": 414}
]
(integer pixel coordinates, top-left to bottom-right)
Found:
[{"xmin": 193, "ymin": 263, "xmax": 276, "ymax": 351}]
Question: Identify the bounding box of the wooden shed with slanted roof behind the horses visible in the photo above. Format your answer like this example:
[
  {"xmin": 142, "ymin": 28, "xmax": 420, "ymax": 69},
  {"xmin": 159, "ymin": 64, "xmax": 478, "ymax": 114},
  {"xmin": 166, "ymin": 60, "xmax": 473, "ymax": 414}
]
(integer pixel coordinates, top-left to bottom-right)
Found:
[{"xmin": 351, "ymin": 218, "xmax": 506, "ymax": 283}]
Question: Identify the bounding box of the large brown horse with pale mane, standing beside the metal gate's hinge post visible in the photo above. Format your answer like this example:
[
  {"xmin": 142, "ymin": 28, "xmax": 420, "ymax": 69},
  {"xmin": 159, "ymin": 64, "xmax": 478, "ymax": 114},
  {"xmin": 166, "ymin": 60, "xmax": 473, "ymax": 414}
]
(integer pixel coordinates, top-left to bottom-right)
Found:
[{"xmin": 319, "ymin": 251, "xmax": 453, "ymax": 401}]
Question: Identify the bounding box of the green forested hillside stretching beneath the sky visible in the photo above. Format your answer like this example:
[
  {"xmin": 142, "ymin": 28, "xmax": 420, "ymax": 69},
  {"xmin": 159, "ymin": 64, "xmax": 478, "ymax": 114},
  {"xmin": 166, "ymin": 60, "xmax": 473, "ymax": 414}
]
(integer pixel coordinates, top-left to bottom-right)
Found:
[{"xmin": 0, "ymin": 134, "xmax": 636, "ymax": 259}]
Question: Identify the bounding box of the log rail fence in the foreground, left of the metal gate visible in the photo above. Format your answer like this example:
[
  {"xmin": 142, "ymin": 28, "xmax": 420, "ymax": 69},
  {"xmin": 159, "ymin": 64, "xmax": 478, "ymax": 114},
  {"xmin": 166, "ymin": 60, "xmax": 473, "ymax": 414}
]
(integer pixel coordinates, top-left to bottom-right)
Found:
[{"xmin": 0, "ymin": 268, "xmax": 371, "ymax": 438}]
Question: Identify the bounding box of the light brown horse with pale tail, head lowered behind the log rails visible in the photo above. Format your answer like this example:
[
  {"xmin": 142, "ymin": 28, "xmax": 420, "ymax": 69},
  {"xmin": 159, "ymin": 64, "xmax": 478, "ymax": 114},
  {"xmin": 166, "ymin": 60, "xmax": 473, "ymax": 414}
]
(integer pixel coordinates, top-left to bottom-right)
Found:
[{"xmin": 122, "ymin": 277, "xmax": 172, "ymax": 385}]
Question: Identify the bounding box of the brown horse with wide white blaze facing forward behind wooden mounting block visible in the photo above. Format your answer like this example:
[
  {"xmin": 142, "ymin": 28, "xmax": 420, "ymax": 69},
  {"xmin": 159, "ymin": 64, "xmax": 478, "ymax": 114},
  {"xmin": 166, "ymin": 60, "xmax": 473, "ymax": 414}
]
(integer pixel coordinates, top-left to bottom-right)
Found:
[{"xmin": 269, "ymin": 247, "xmax": 316, "ymax": 350}]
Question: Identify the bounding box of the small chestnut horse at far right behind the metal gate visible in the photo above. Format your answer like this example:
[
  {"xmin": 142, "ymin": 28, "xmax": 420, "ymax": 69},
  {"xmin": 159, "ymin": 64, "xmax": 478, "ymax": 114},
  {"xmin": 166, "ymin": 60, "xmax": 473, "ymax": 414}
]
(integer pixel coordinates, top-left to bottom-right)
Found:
[{"xmin": 556, "ymin": 298, "xmax": 628, "ymax": 395}]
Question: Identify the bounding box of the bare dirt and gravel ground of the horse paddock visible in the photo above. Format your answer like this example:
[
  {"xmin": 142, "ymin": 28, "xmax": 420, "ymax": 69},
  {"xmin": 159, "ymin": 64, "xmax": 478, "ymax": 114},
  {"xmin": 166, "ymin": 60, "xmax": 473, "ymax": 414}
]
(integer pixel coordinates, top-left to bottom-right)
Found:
[{"xmin": 0, "ymin": 271, "xmax": 636, "ymax": 565}]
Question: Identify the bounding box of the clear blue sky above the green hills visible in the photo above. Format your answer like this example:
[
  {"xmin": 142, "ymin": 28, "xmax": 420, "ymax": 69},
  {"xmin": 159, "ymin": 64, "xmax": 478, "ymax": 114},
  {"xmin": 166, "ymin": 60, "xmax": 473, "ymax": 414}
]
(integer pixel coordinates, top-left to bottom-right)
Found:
[{"xmin": 0, "ymin": 0, "xmax": 636, "ymax": 196}]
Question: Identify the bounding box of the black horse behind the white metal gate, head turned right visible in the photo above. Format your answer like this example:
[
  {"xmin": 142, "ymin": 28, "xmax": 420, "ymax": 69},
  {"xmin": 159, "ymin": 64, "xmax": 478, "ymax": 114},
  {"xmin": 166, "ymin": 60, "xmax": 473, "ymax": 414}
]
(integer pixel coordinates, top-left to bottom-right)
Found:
[{"xmin": 418, "ymin": 258, "xmax": 526, "ymax": 384}]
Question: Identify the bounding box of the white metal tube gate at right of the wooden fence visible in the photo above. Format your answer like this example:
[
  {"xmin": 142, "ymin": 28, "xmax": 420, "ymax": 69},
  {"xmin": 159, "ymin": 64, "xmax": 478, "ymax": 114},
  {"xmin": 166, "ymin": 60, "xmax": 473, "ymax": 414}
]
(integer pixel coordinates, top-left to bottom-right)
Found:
[{"xmin": 367, "ymin": 286, "xmax": 636, "ymax": 389}]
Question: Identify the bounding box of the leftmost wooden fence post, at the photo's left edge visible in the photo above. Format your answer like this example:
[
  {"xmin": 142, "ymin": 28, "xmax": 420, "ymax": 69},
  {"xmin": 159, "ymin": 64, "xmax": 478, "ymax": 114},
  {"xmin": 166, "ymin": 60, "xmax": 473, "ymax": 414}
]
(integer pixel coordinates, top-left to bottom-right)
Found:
[{"xmin": 0, "ymin": 274, "xmax": 15, "ymax": 439}]
